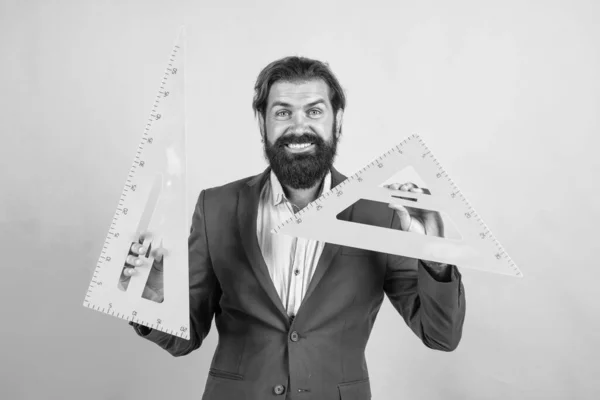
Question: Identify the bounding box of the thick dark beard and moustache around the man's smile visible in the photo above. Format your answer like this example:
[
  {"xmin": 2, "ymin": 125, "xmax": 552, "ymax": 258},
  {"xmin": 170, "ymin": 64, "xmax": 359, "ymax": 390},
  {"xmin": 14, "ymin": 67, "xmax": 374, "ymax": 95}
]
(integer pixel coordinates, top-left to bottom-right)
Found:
[{"xmin": 264, "ymin": 123, "xmax": 338, "ymax": 189}]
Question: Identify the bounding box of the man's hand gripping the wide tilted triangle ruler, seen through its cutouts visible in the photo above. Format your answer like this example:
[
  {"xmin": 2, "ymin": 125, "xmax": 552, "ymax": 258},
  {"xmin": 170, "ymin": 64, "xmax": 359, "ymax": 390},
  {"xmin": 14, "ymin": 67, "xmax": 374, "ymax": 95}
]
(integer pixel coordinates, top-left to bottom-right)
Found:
[{"xmin": 385, "ymin": 182, "xmax": 444, "ymax": 237}]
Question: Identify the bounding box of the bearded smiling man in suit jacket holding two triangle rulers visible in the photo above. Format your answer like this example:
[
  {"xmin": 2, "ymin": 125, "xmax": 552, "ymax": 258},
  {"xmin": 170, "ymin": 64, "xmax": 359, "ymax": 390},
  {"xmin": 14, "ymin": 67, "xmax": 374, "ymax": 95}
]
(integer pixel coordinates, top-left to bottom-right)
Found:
[{"xmin": 123, "ymin": 57, "xmax": 465, "ymax": 400}]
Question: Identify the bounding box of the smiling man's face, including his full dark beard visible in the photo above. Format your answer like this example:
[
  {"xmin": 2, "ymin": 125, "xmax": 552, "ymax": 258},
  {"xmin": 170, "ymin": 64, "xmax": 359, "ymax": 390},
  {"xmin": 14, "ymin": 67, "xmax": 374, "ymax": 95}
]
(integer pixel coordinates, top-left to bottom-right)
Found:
[{"xmin": 259, "ymin": 79, "xmax": 341, "ymax": 189}]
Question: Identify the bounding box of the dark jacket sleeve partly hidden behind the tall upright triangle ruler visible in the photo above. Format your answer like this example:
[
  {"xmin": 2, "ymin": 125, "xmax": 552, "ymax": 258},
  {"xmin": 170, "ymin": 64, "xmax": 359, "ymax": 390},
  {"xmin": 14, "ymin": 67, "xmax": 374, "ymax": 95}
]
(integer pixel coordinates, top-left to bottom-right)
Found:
[{"xmin": 132, "ymin": 190, "xmax": 221, "ymax": 357}]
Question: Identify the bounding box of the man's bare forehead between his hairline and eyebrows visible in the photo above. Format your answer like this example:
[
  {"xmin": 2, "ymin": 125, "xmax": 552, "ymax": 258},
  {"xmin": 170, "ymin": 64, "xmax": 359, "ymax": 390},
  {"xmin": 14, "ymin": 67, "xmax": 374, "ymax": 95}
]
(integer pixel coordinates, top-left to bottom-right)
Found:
[{"xmin": 267, "ymin": 79, "xmax": 331, "ymax": 106}]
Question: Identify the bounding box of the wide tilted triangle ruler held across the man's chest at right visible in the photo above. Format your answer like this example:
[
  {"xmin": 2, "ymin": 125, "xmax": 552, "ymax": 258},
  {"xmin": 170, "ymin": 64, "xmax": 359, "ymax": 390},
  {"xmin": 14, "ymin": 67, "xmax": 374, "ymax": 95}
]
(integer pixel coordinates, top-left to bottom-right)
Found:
[{"xmin": 273, "ymin": 134, "xmax": 522, "ymax": 277}]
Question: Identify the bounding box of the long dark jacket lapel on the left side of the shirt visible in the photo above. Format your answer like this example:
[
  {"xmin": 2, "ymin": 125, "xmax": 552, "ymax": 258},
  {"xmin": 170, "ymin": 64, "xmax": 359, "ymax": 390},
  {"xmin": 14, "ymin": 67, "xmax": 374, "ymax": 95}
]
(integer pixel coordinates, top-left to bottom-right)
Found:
[{"xmin": 237, "ymin": 168, "xmax": 288, "ymax": 320}]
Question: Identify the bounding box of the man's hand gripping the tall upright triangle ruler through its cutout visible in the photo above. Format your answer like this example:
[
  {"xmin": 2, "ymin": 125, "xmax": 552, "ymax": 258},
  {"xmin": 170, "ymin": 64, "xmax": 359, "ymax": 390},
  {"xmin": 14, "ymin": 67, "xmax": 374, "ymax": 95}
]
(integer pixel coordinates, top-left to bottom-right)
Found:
[{"xmin": 119, "ymin": 232, "xmax": 167, "ymax": 303}]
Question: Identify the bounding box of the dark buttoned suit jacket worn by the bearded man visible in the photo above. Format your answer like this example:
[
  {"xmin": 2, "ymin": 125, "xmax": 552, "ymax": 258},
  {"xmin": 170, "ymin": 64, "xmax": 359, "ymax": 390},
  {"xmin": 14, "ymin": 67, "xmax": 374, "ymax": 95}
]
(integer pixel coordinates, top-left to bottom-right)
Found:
[{"xmin": 136, "ymin": 168, "xmax": 465, "ymax": 400}]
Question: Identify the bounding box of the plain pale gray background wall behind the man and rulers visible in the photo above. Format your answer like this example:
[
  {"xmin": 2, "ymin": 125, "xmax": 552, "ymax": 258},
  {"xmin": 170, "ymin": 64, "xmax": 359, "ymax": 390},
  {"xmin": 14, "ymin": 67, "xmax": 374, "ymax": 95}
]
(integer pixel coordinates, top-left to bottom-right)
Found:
[{"xmin": 0, "ymin": 0, "xmax": 600, "ymax": 400}]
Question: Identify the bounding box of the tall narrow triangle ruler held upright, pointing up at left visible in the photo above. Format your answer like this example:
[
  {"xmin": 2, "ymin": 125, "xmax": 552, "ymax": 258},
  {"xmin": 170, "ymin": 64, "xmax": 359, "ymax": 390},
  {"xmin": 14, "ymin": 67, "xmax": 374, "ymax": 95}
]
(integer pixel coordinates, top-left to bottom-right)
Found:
[{"xmin": 84, "ymin": 28, "xmax": 189, "ymax": 340}]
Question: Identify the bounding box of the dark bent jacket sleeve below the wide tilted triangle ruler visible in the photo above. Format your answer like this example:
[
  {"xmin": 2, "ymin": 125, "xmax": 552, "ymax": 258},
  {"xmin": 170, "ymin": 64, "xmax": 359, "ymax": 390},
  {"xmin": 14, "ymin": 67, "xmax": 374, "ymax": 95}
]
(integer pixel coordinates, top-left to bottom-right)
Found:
[{"xmin": 384, "ymin": 213, "xmax": 466, "ymax": 351}]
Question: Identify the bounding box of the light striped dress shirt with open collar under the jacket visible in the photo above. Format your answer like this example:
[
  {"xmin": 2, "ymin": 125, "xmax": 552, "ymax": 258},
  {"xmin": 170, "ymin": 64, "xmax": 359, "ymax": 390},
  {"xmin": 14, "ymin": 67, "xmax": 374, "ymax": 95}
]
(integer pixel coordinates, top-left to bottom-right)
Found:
[{"xmin": 256, "ymin": 171, "xmax": 331, "ymax": 317}]
